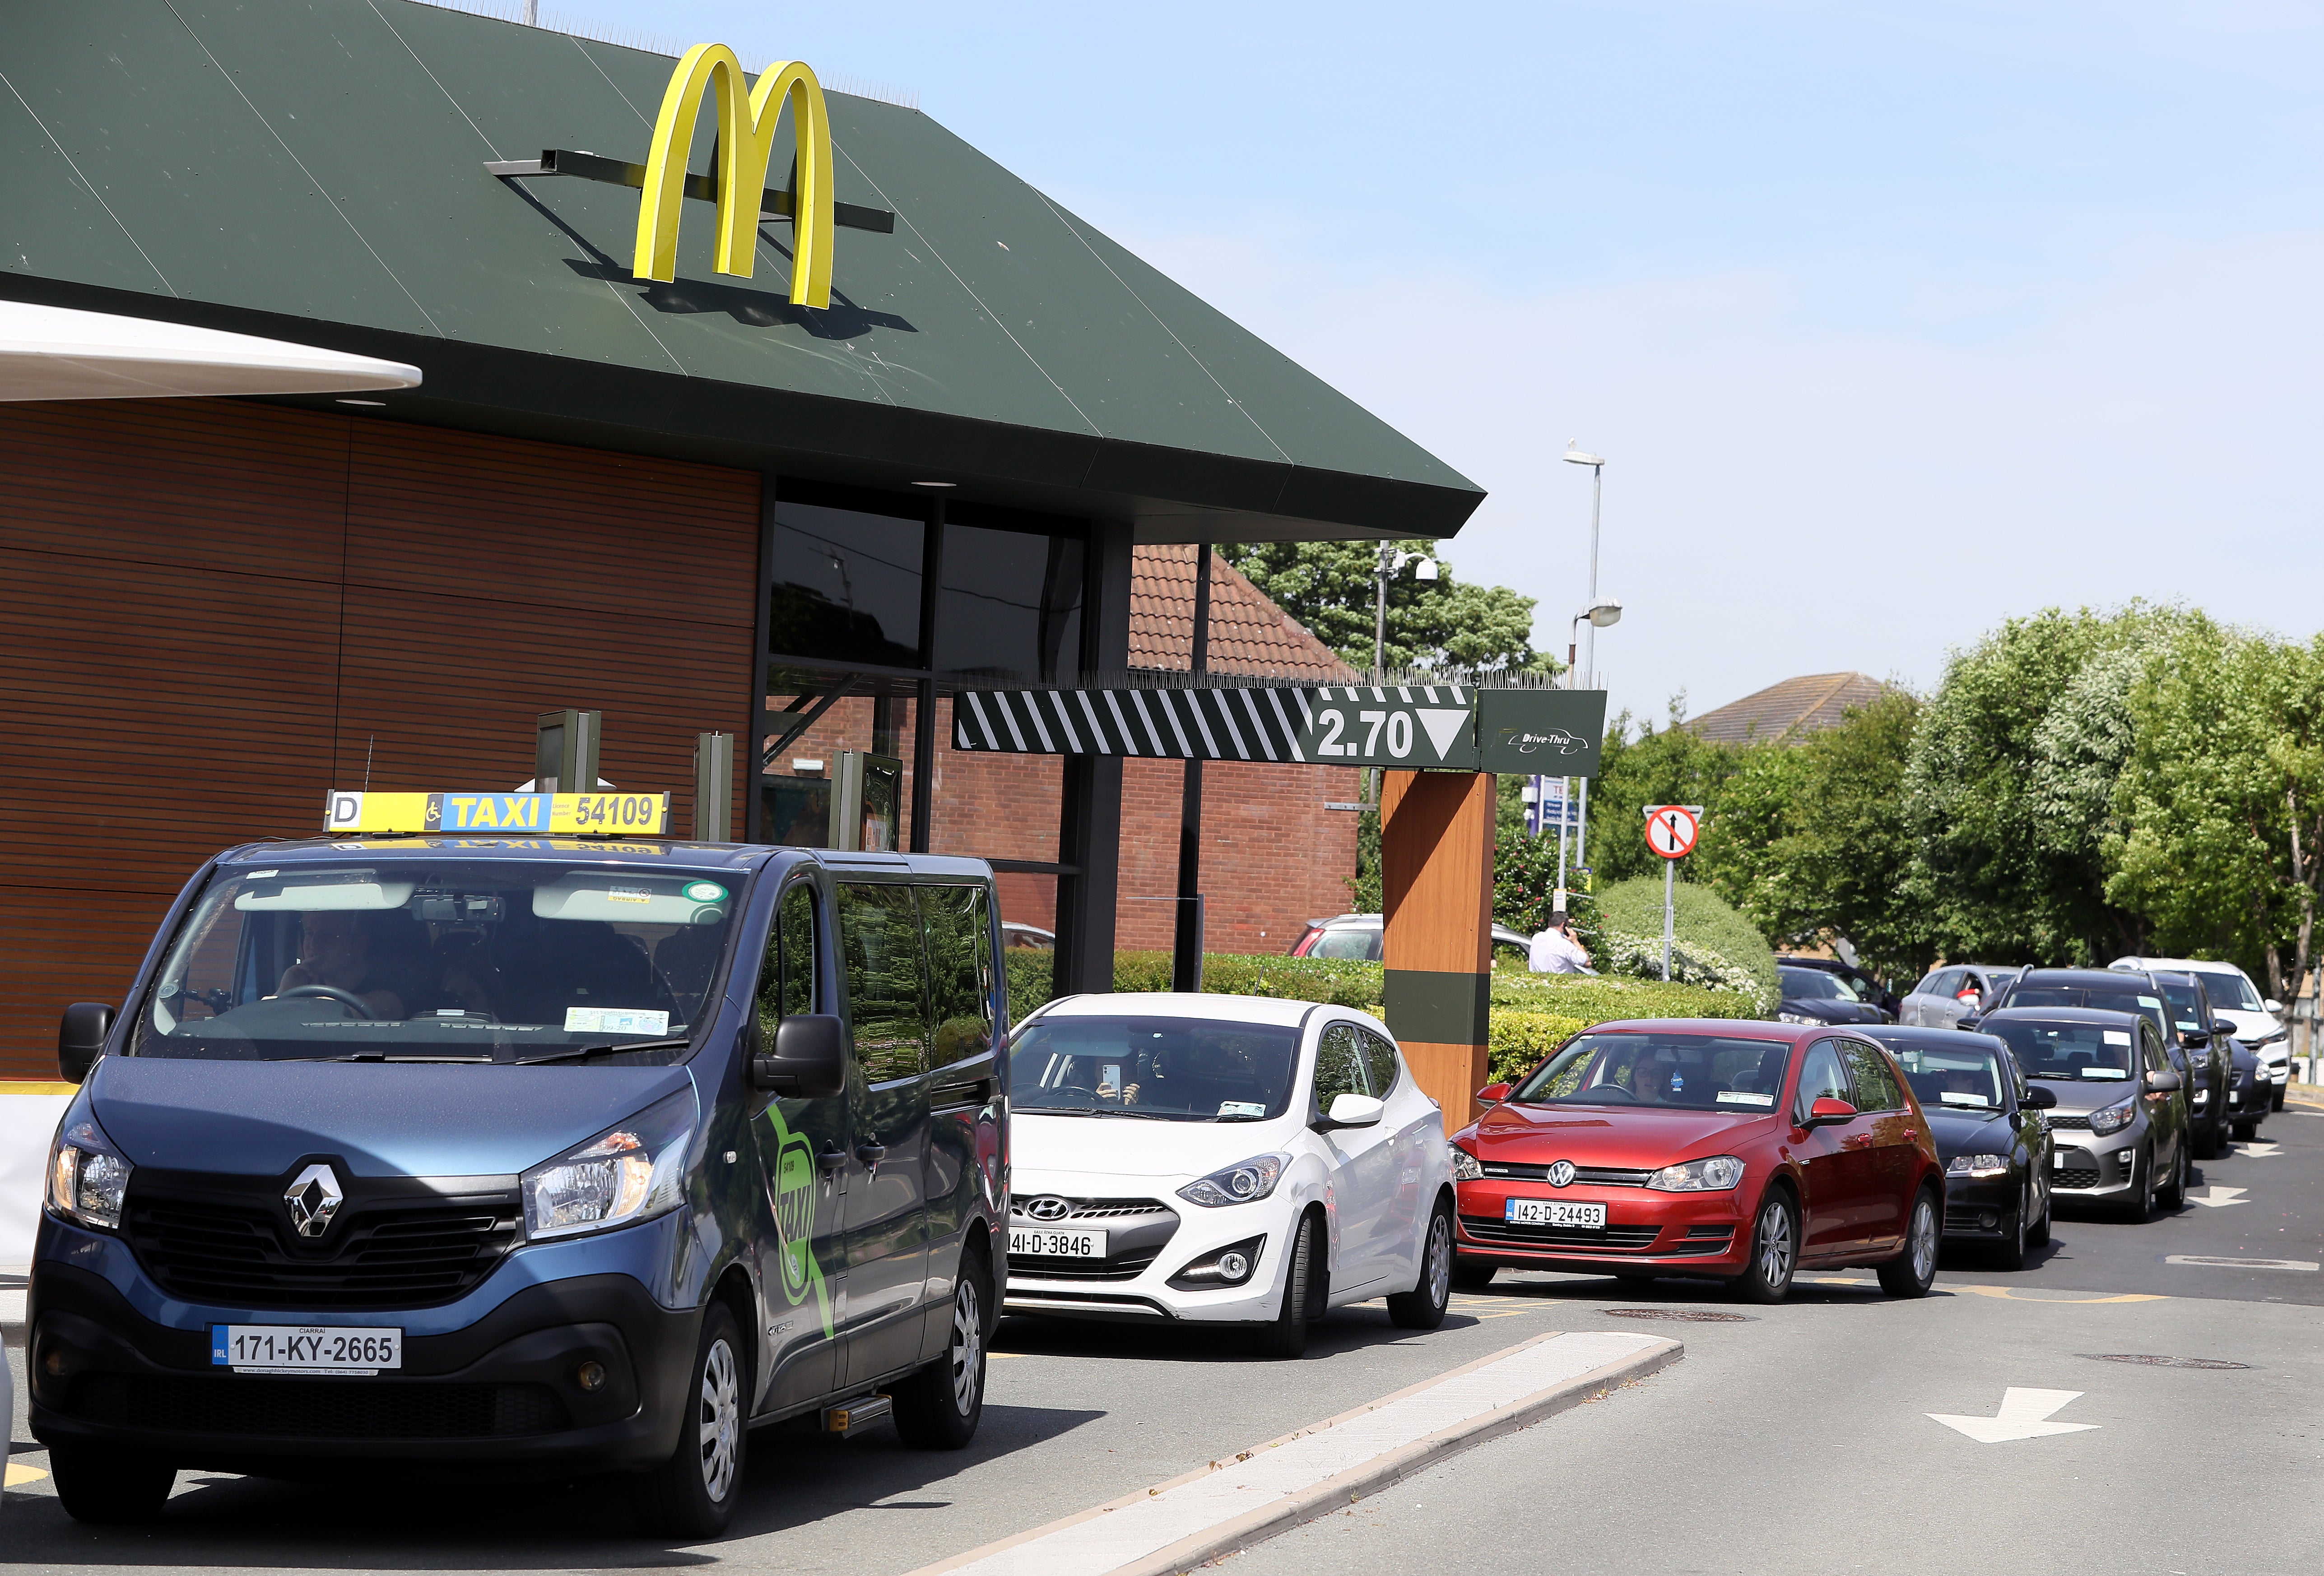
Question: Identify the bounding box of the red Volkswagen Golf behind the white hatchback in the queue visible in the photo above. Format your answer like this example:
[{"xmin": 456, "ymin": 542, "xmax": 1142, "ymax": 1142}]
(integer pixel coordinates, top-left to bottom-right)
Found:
[{"xmin": 1453, "ymin": 1018, "xmax": 1945, "ymax": 1302}]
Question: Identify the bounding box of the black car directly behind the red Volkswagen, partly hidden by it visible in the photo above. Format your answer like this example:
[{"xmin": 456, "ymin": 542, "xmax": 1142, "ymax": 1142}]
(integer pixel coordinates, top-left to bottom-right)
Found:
[{"xmin": 1866, "ymin": 1027, "xmax": 2057, "ymax": 1269}]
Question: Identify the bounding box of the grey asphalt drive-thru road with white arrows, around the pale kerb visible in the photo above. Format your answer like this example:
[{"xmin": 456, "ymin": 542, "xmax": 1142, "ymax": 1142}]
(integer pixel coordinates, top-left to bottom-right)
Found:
[{"xmin": 0, "ymin": 1113, "xmax": 2324, "ymax": 1576}]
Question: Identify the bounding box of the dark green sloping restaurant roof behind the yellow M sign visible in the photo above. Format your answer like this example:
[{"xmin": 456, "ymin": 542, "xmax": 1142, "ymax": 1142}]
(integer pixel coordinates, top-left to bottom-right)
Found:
[{"xmin": 0, "ymin": 0, "xmax": 1483, "ymax": 539}]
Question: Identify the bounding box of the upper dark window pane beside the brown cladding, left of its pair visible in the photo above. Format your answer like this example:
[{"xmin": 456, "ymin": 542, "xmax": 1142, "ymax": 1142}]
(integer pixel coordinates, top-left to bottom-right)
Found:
[{"xmin": 767, "ymin": 502, "xmax": 927, "ymax": 667}]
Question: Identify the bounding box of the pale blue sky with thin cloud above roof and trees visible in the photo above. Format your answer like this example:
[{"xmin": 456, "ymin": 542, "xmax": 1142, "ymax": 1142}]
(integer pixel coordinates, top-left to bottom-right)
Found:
[{"xmin": 499, "ymin": 0, "xmax": 2324, "ymax": 714}]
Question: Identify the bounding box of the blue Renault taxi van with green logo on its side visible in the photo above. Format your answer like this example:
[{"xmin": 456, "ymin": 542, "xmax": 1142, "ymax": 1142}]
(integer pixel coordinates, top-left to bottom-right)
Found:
[{"xmin": 28, "ymin": 795, "xmax": 1009, "ymax": 1536}]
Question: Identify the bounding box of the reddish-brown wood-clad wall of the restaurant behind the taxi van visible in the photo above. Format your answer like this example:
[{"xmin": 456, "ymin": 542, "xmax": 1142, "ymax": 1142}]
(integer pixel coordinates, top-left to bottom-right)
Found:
[{"xmin": 0, "ymin": 400, "xmax": 760, "ymax": 1076}]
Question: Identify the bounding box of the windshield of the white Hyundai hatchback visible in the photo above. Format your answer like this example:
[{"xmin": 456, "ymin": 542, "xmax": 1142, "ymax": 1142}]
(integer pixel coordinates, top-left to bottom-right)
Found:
[{"xmin": 1009, "ymin": 1016, "xmax": 1299, "ymax": 1123}]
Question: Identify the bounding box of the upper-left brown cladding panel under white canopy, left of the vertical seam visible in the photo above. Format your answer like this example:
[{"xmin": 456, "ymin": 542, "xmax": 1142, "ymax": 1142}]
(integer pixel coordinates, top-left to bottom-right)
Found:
[{"xmin": 0, "ymin": 400, "xmax": 351, "ymax": 583}]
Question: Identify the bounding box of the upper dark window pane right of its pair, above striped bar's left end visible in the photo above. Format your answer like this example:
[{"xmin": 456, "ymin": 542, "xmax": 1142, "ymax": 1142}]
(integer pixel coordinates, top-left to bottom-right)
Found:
[{"xmin": 937, "ymin": 525, "xmax": 1081, "ymax": 679}]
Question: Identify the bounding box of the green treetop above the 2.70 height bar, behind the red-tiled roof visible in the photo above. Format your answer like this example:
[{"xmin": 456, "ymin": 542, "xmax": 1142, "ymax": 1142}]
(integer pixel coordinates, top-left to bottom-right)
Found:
[{"xmin": 1218, "ymin": 539, "xmax": 1562, "ymax": 672}]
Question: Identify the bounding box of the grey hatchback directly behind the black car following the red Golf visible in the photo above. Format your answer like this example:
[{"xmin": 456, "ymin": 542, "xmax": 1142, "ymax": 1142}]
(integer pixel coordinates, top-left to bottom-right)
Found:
[{"xmin": 1982, "ymin": 1006, "xmax": 2192, "ymax": 1220}]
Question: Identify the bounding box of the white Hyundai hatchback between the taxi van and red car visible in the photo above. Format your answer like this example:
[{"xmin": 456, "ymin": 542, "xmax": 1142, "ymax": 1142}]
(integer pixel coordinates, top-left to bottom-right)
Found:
[{"xmin": 1002, "ymin": 995, "xmax": 1453, "ymax": 1358}]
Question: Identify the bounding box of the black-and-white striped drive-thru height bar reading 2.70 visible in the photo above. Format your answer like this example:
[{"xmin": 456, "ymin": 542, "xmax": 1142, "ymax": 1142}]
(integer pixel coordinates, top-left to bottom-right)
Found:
[{"xmin": 953, "ymin": 683, "xmax": 1478, "ymax": 772}]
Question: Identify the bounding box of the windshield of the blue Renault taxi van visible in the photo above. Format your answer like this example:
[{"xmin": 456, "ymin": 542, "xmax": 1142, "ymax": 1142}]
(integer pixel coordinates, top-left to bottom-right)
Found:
[{"xmin": 130, "ymin": 860, "xmax": 737, "ymax": 1065}]
